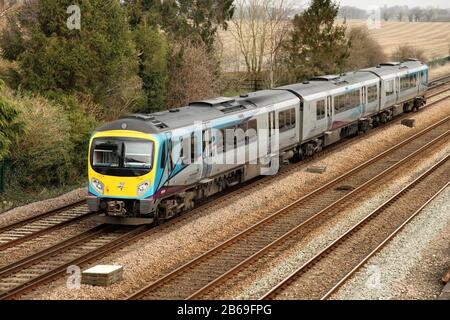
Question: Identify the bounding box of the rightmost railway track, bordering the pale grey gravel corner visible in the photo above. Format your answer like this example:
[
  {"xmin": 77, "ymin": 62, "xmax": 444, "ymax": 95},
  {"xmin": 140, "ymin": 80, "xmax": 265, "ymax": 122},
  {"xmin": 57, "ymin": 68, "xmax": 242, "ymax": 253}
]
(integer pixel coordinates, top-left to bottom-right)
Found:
[{"xmin": 262, "ymin": 154, "xmax": 450, "ymax": 299}]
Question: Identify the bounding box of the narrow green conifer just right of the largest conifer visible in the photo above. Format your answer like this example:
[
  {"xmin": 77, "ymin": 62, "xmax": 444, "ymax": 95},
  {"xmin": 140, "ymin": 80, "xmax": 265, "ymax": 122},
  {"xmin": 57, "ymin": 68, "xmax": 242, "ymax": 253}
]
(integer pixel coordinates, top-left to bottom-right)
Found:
[{"xmin": 133, "ymin": 22, "xmax": 168, "ymax": 112}]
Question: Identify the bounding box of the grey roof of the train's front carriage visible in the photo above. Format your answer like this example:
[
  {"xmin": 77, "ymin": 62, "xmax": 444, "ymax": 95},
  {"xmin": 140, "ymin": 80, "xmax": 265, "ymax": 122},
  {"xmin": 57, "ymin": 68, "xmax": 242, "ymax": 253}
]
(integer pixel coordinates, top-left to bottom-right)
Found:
[{"xmin": 97, "ymin": 90, "xmax": 298, "ymax": 134}]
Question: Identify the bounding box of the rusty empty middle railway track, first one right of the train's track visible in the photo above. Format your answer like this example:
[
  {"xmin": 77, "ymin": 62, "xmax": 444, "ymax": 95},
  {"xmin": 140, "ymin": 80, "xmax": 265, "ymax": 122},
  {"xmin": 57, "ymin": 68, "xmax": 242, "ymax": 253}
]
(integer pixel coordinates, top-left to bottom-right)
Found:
[{"xmin": 128, "ymin": 117, "xmax": 450, "ymax": 299}]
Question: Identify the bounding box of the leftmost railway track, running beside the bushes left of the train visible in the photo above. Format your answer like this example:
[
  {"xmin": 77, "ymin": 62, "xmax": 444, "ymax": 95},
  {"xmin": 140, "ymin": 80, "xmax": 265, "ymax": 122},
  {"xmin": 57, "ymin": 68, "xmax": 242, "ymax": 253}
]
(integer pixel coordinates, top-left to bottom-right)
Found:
[{"xmin": 0, "ymin": 201, "xmax": 93, "ymax": 250}]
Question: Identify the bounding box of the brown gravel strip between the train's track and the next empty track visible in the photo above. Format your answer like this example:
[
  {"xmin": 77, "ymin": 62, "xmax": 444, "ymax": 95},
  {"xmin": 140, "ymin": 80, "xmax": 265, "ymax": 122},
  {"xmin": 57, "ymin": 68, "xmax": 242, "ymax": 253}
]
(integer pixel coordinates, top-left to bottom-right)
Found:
[{"xmin": 21, "ymin": 102, "xmax": 450, "ymax": 299}]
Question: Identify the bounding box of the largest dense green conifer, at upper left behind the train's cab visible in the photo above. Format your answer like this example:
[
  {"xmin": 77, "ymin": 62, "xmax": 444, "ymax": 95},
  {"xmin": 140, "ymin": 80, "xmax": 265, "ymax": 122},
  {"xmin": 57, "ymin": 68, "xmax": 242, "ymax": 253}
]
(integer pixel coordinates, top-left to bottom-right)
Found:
[{"xmin": 1, "ymin": 0, "xmax": 138, "ymax": 114}]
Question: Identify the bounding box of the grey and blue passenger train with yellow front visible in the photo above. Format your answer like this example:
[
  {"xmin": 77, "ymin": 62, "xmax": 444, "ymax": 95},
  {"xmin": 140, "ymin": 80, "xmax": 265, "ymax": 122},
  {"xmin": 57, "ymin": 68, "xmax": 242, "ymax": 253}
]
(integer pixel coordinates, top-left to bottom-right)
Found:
[{"xmin": 86, "ymin": 59, "xmax": 429, "ymax": 225}]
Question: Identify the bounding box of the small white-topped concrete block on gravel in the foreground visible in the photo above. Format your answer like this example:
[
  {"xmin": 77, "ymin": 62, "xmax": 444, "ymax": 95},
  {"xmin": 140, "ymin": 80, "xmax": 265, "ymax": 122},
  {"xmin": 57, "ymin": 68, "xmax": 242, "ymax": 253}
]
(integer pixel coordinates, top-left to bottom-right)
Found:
[{"xmin": 81, "ymin": 265, "xmax": 123, "ymax": 287}]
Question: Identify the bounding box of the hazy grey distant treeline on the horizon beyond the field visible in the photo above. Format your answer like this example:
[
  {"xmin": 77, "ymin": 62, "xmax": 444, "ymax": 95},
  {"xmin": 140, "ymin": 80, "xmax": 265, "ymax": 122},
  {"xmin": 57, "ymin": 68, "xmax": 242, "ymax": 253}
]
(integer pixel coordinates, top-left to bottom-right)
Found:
[{"xmin": 338, "ymin": 6, "xmax": 450, "ymax": 22}]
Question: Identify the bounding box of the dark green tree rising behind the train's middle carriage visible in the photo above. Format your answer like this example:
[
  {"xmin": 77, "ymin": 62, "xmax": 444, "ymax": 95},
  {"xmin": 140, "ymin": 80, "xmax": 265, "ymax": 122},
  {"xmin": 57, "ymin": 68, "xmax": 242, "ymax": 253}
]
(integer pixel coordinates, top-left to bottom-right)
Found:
[{"xmin": 285, "ymin": 0, "xmax": 349, "ymax": 82}]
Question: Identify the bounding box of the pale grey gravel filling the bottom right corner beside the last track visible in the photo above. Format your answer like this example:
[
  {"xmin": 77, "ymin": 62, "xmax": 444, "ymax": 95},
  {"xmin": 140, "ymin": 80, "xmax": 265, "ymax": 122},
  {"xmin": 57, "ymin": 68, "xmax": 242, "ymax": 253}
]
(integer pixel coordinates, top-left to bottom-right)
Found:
[{"xmin": 331, "ymin": 187, "xmax": 450, "ymax": 299}]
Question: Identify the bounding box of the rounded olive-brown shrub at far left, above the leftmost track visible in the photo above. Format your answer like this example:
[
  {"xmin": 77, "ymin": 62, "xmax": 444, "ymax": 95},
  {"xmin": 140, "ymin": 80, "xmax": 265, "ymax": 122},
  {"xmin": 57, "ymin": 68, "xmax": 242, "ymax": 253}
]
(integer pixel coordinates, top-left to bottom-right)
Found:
[{"xmin": 11, "ymin": 96, "xmax": 73, "ymax": 190}]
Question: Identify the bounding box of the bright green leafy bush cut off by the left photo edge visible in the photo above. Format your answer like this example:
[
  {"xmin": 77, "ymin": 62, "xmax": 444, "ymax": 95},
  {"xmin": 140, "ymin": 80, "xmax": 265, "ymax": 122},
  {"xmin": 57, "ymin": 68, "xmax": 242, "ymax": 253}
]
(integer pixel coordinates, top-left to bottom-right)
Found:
[{"xmin": 0, "ymin": 80, "xmax": 24, "ymax": 159}]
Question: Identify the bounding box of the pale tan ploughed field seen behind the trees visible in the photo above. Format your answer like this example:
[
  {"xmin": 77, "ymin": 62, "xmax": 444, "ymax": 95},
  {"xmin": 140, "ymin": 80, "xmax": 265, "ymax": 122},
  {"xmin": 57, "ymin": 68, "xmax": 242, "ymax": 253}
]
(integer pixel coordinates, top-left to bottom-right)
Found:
[{"xmin": 219, "ymin": 20, "xmax": 450, "ymax": 71}]
